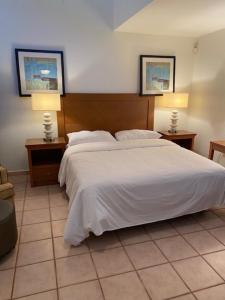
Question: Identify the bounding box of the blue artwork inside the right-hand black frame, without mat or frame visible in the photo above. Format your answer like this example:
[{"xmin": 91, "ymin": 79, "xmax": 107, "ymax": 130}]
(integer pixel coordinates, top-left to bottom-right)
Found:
[{"xmin": 146, "ymin": 62, "xmax": 170, "ymax": 91}]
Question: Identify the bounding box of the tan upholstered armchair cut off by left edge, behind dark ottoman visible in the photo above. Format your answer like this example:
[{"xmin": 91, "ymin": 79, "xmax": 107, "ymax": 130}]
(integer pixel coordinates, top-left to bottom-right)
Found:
[{"xmin": 0, "ymin": 165, "xmax": 14, "ymax": 203}]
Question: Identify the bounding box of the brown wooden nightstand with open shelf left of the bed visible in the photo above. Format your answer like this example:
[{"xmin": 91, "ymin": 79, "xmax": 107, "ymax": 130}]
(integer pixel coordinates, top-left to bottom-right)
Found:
[{"xmin": 25, "ymin": 137, "xmax": 66, "ymax": 186}]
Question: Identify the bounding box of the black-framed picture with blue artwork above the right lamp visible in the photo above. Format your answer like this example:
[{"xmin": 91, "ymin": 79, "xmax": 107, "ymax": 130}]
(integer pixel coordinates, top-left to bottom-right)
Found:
[{"xmin": 140, "ymin": 55, "xmax": 176, "ymax": 96}]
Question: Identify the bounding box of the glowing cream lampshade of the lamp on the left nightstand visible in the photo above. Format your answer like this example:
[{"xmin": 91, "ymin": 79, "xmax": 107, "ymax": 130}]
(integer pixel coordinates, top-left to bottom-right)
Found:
[{"xmin": 32, "ymin": 93, "xmax": 61, "ymax": 111}]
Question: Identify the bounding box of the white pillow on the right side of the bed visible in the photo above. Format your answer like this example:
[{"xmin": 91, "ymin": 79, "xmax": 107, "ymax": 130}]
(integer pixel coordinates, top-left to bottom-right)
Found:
[{"xmin": 115, "ymin": 129, "xmax": 162, "ymax": 141}]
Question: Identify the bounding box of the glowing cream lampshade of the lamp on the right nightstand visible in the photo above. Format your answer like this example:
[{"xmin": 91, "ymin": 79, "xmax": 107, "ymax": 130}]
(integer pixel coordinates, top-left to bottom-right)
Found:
[{"xmin": 157, "ymin": 93, "xmax": 188, "ymax": 108}]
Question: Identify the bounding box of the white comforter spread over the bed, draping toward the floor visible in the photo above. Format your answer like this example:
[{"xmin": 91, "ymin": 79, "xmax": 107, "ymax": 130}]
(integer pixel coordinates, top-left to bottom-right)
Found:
[{"xmin": 59, "ymin": 139, "xmax": 225, "ymax": 245}]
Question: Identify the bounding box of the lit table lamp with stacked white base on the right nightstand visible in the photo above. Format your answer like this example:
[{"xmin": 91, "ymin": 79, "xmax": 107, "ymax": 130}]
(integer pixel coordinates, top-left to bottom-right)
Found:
[{"xmin": 158, "ymin": 93, "xmax": 188, "ymax": 133}]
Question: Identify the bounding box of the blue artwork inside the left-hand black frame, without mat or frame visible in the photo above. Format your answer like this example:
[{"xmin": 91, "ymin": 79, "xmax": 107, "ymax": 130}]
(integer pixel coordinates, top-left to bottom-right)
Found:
[{"xmin": 24, "ymin": 57, "xmax": 58, "ymax": 91}]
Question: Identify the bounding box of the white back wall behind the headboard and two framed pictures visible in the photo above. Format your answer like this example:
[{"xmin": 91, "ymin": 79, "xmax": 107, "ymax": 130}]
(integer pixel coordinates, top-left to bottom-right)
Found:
[{"xmin": 0, "ymin": 0, "xmax": 193, "ymax": 170}]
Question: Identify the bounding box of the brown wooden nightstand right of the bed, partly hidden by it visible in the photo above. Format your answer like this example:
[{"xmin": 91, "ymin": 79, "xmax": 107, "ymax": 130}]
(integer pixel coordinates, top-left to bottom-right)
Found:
[{"xmin": 159, "ymin": 130, "xmax": 197, "ymax": 150}]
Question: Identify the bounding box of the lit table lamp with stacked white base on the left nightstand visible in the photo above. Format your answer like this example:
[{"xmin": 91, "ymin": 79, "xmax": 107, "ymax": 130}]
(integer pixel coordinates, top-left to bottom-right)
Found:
[{"xmin": 32, "ymin": 93, "xmax": 61, "ymax": 142}]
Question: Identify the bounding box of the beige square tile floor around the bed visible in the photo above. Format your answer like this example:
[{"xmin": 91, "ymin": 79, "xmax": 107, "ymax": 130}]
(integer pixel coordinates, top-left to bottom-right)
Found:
[{"xmin": 0, "ymin": 176, "xmax": 225, "ymax": 300}]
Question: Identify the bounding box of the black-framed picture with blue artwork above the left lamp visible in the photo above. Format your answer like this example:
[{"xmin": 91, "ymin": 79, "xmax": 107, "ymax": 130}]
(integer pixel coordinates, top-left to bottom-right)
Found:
[{"xmin": 15, "ymin": 49, "xmax": 65, "ymax": 97}]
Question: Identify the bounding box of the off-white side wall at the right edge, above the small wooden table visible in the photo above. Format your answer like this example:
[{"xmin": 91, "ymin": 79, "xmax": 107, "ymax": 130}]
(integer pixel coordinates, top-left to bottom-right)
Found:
[{"xmin": 188, "ymin": 30, "xmax": 225, "ymax": 156}]
